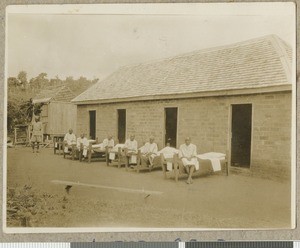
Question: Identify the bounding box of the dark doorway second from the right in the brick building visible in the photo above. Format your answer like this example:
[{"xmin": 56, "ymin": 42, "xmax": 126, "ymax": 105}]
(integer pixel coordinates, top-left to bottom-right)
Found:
[{"xmin": 165, "ymin": 108, "xmax": 177, "ymax": 147}]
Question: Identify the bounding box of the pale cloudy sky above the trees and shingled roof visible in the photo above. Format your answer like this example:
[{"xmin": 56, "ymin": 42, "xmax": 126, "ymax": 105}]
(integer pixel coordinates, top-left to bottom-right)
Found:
[{"xmin": 6, "ymin": 3, "xmax": 295, "ymax": 79}]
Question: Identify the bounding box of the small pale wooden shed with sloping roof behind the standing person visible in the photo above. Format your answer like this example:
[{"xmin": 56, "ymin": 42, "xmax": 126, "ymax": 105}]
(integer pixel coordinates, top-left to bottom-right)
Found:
[{"xmin": 33, "ymin": 86, "xmax": 77, "ymax": 137}]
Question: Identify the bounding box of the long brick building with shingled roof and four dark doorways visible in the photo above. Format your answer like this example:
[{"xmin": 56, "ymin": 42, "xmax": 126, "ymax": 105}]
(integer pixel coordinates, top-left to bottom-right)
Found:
[{"xmin": 72, "ymin": 35, "xmax": 292, "ymax": 178}]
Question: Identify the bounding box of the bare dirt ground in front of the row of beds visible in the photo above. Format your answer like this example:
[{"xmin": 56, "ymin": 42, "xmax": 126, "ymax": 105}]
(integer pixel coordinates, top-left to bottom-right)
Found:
[{"xmin": 7, "ymin": 147, "xmax": 291, "ymax": 228}]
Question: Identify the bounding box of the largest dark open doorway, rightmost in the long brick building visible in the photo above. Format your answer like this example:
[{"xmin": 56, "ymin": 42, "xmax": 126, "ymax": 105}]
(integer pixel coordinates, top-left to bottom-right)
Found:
[{"xmin": 231, "ymin": 104, "xmax": 252, "ymax": 168}]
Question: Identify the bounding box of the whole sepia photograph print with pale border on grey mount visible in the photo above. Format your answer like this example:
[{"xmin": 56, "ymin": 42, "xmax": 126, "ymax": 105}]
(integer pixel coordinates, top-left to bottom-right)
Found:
[{"xmin": 3, "ymin": 2, "xmax": 296, "ymax": 233}]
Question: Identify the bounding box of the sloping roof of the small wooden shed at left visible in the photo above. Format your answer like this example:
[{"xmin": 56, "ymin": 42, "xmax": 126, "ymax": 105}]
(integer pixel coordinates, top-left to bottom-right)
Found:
[{"xmin": 33, "ymin": 86, "xmax": 76, "ymax": 103}]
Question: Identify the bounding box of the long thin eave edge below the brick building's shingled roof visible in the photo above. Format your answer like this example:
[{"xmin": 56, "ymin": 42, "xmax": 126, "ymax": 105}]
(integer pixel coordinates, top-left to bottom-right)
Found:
[{"xmin": 71, "ymin": 84, "xmax": 292, "ymax": 105}]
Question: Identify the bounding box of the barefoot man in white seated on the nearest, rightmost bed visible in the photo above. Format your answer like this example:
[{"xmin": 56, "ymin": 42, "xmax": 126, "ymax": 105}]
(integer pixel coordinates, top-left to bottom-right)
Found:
[{"xmin": 179, "ymin": 137, "xmax": 199, "ymax": 184}]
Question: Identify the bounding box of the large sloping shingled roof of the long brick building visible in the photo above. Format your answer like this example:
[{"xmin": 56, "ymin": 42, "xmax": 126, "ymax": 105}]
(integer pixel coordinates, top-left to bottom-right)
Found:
[{"xmin": 72, "ymin": 35, "xmax": 292, "ymax": 104}]
